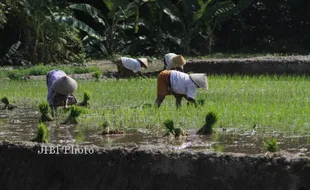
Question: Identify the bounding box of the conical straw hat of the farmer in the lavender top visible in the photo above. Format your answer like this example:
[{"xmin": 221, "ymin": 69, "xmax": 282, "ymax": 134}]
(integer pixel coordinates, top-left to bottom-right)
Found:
[{"xmin": 52, "ymin": 76, "xmax": 78, "ymax": 94}]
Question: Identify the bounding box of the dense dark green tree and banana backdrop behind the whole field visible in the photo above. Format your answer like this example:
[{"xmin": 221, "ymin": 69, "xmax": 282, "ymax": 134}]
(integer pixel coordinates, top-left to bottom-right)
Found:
[{"xmin": 0, "ymin": 0, "xmax": 310, "ymax": 65}]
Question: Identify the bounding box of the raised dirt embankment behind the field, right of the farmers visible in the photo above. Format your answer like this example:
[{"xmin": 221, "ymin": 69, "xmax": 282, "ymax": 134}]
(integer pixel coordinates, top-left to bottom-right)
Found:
[{"xmin": 184, "ymin": 56, "xmax": 310, "ymax": 75}]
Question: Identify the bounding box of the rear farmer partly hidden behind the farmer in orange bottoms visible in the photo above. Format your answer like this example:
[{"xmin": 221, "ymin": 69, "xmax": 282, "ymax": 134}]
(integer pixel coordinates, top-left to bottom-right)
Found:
[{"xmin": 164, "ymin": 53, "xmax": 186, "ymax": 72}]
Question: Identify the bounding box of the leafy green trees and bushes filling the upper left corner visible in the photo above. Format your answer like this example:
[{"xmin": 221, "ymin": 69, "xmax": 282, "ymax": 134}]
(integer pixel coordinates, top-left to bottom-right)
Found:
[{"xmin": 0, "ymin": 0, "xmax": 85, "ymax": 64}]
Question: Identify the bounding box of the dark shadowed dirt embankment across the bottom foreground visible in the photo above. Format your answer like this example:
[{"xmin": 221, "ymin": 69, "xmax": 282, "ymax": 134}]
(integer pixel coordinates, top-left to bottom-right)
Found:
[{"xmin": 0, "ymin": 142, "xmax": 310, "ymax": 190}]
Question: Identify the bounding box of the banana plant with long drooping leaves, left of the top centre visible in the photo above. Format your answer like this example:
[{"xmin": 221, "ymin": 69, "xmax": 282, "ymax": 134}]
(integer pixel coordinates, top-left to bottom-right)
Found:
[{"xmin": 55, "ymin": 0, "xmax": 152, "ymax": 55}]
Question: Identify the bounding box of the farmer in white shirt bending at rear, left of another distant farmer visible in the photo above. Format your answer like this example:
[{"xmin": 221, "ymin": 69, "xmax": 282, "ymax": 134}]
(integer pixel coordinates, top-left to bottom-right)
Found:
[{"xmin": 117, "ymin": 57, "xmax": 148, "ymax": 78}]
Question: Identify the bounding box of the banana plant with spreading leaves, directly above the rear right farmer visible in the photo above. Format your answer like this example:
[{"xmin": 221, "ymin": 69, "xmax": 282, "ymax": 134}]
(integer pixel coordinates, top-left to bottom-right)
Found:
[{"xmin": 157, "ymin": 0, "xmax": 240, "ymax": 54}]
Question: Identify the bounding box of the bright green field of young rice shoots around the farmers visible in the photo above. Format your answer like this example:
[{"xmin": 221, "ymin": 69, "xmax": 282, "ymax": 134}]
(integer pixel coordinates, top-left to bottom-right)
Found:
[{"xmin": 0, "ymin": 76, "xmax": 310, "ymax": 134}]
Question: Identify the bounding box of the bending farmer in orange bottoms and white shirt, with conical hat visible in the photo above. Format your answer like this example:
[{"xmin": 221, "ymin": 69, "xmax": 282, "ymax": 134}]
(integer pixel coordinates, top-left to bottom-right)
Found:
[{"xmin": 155, "ymin": 70, "xmax": 208, "ymax": 107}]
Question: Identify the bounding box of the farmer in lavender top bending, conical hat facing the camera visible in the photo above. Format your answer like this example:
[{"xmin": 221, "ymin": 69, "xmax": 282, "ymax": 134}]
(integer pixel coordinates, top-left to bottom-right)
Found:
[{"xmin": 46, "ymin": 70, "xmax": 78, "ymax": 117}]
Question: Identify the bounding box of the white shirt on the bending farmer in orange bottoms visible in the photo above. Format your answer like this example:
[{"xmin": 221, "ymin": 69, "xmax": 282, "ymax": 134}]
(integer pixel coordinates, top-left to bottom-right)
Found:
[{"xmin": 170, "ymin": 70, "xmax": 197, "ymax": 99}]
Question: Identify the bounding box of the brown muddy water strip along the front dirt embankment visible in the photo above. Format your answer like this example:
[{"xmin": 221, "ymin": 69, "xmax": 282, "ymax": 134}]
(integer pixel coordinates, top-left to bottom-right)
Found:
[{"xmin": 0, "ymin": 108, "xmax": 310, "ymax": 156}]
